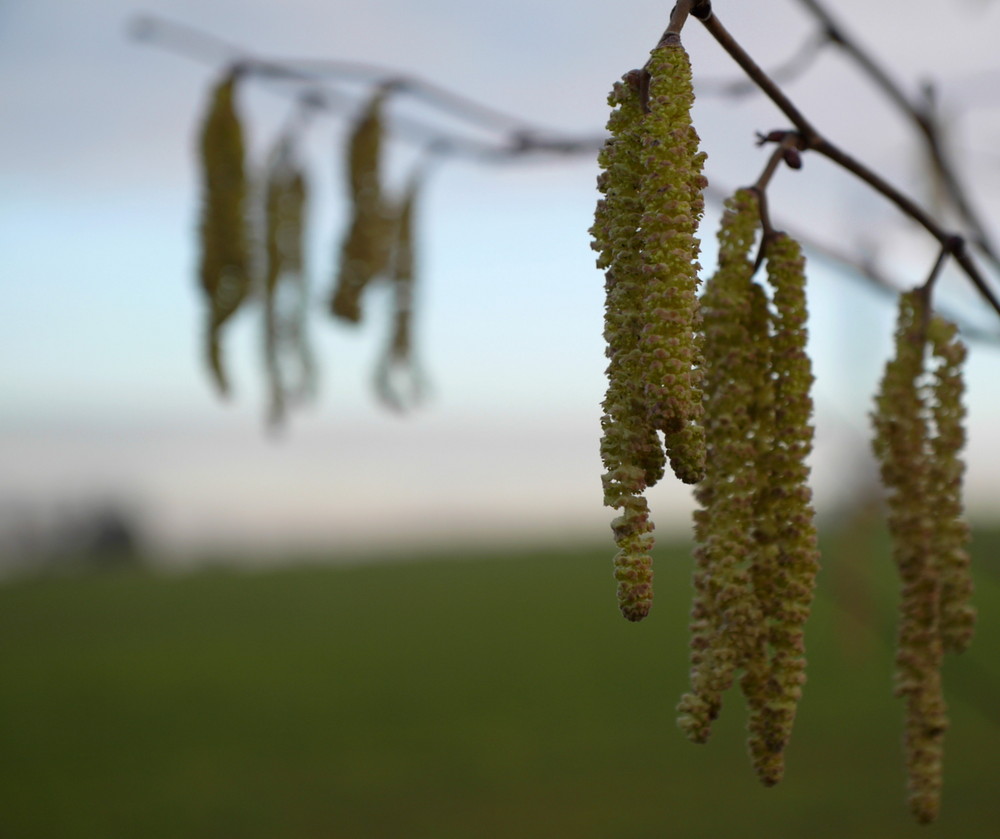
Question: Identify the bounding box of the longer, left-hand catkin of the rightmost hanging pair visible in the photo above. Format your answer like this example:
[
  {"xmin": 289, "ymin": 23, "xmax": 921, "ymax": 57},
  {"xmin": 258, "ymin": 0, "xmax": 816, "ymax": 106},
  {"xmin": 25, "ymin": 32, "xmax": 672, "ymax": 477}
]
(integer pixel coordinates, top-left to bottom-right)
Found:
[{"xmin": 873, "ymin": 289, "xmax": 948, "ymax": 823}]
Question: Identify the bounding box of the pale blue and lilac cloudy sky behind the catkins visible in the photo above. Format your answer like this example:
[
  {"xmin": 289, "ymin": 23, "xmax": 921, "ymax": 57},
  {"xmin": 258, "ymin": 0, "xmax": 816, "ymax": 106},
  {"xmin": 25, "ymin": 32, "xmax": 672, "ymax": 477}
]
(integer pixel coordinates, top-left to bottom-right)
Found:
[{"xmin": 0, "ymin": 0, "xmax": 1000, "ymax": 557}]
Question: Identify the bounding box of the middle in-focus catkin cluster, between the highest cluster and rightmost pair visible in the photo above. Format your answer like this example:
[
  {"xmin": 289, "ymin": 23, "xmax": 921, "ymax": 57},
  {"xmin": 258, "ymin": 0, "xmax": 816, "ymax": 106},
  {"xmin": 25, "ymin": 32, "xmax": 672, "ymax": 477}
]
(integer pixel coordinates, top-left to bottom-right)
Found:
[{"xmin": 678, "ymin": 190, "xmax": 818, "ymax": 785}]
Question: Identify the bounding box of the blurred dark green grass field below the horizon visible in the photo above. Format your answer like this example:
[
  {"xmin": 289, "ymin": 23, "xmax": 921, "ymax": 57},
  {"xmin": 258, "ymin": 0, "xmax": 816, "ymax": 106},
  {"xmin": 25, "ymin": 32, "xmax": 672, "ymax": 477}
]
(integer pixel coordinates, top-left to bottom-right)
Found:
[{"xmin": 0, "ymin": 533, "xmax": 1000, "ymax": 839}]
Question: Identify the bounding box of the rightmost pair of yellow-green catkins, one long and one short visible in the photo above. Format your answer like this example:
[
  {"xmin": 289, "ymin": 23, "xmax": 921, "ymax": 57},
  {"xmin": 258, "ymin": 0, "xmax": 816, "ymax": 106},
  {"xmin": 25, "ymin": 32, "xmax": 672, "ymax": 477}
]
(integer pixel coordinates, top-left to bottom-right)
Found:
[{"xmin": 872, "ymin": 289, "xmax": 975, "ymax": 823}]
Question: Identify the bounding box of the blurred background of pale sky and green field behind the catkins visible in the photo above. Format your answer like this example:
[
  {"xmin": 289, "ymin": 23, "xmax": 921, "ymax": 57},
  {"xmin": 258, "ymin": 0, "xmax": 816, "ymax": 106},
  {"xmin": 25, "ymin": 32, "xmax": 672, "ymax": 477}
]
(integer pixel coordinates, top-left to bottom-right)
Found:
[{"xmin": 0, "ymin": 0, "xmax": 1000, "ymax": 837}]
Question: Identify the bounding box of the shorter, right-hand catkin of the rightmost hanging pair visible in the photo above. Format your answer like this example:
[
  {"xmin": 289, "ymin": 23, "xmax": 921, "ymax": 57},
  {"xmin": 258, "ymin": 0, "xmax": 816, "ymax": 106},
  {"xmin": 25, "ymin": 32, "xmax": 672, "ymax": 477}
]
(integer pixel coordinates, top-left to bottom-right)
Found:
[{"xmin": 928, "ymin": 316, "xmax": 976, "ymax": 653}]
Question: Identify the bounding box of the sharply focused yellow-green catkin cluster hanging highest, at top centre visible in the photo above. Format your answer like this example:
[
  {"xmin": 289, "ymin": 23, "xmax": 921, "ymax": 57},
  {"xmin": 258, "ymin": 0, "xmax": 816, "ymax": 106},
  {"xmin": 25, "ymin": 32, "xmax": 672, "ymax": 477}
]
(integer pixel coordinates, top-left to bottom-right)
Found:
[{"xmin": 591, "ymin": 43, "xmax": 705, "ymax": 621}]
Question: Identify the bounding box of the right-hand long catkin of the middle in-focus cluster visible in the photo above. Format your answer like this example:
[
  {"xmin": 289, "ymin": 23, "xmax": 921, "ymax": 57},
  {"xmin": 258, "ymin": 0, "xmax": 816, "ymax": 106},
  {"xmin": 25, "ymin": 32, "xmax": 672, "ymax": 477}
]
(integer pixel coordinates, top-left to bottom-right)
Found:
[{"xmin": 742, "ymin": 233, "xmax": 819, "ymax": 786}]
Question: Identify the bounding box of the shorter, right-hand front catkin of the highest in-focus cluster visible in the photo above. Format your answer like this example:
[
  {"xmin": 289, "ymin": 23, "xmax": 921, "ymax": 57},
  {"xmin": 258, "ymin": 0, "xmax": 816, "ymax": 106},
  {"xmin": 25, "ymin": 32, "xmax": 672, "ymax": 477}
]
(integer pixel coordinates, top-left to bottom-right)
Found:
[{"xmin": 639, "ymin": 41, "xmax": 707, "ymax": 483}]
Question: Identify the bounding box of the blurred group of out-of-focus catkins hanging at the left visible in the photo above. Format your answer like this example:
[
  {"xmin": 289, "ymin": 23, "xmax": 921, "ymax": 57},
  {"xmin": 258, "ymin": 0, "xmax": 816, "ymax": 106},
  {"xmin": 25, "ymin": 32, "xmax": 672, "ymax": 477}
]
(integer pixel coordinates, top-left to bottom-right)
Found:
[{"xmin": 193, "ymin": 74, "xmax": 425, "ymax": 425}]
